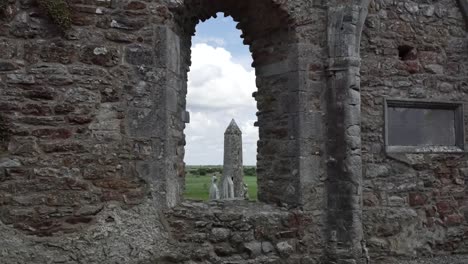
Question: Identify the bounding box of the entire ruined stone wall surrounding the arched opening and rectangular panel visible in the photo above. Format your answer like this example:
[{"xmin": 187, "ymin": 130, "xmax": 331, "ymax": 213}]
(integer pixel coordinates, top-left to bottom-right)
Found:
[{"xmin": 0, "ymin": 0, "xmax": 468, "ymax": 264}]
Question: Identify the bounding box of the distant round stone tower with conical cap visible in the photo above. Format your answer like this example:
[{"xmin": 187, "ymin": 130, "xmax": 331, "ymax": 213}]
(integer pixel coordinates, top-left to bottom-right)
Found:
[{"xmin": 221, "ymin": 119, "xmax": 244, "ymax": 198}]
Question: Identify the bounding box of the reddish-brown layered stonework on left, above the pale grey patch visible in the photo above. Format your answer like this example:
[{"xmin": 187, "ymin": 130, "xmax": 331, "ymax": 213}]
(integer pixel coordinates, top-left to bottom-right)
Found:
[{"xmin": 0, "ymin": 1, "xmax": 157, "ymax": 236}]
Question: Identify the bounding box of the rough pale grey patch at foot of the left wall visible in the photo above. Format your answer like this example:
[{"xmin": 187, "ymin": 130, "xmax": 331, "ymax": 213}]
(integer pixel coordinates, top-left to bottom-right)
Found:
[{"xmin": 0, "ymin": 203, "xmax": 171, "ymax": 264}]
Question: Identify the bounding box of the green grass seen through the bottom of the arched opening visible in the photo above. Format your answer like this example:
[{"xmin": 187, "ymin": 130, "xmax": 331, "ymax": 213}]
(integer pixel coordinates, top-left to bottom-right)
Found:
[{"xmin": 184, "ymin": 174, "xmax": 257, "ymax": 201}]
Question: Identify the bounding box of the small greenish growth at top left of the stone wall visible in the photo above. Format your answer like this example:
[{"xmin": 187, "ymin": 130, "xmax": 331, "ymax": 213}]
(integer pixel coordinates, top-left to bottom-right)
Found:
[{"xmin": 37, "ymin": 0, "xmax": 71, "ymax": 30}]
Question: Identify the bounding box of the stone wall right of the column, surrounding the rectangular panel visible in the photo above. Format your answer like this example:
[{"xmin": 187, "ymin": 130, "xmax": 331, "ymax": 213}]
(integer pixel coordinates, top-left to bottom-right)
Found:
[{"xmin": 361, "ymin": 1, "xmax": 468, "ymax": 258}]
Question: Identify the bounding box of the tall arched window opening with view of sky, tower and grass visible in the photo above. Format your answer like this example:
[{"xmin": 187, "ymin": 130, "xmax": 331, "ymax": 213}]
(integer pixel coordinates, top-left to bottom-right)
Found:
[{"xmin": 184, "ymin": 13, "xmax": 258, "ymax": 201}]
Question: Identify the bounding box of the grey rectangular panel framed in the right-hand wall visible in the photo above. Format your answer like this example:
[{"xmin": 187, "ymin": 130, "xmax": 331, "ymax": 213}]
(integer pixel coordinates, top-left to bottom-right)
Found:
[{"xmin": 385, "ymin": 99, "xmax": 465, "ymax": 153}]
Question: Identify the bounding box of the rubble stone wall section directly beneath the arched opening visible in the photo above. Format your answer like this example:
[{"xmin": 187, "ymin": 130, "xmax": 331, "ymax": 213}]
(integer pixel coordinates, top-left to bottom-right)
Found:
[{"xmin": 164, "ymin": 201, "xmax": 321, "ymax": 263}]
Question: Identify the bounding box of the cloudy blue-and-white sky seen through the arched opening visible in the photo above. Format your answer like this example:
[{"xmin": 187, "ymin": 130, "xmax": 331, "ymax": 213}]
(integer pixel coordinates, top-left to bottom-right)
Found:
[{"xmin": 185, "ymin": 14, "xmax": 258, "ymax": 165}]
